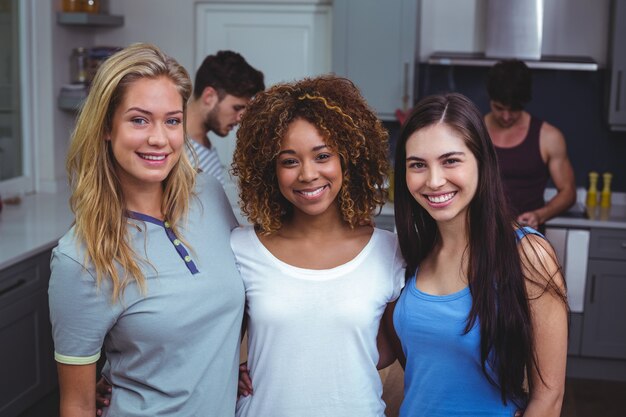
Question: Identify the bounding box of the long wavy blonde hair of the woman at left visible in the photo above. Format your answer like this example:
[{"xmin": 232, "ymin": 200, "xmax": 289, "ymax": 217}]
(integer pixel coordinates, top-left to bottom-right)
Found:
[{"xmin": 66, "ymin": 43, "xmax": 195, "ymax": 301}]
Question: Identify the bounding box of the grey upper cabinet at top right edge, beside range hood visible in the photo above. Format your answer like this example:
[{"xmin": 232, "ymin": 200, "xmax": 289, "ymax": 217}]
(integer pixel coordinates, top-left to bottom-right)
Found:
[{"xmin": 609, "ymin": 0, "xmax": 626, "ymax": 131}]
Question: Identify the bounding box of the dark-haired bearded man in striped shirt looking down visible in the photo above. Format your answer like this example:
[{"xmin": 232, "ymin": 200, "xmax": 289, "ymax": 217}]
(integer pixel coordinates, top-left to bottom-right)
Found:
[{"xmin": 187, "ymin": 51, "xmax": 265, "ymax": 185}]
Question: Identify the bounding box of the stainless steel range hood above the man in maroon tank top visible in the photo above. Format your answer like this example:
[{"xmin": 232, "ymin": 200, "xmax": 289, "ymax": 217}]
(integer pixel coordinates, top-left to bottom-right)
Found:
[{"xmin": 428, "ymin": 0, "xmax": 598, "ymax": 71}]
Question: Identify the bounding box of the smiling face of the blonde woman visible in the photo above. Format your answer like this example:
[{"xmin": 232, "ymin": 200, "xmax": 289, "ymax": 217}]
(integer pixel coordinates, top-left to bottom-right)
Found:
[{"xmin": 107, "ymin": 77, "xmax": 184, "ymax": 192}]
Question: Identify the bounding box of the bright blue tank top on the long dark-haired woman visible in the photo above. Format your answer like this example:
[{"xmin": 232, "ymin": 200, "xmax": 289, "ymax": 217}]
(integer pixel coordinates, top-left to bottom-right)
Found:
[{"xmin": 393, "ymin": 228, "xmax": 539, "ymax": 417}]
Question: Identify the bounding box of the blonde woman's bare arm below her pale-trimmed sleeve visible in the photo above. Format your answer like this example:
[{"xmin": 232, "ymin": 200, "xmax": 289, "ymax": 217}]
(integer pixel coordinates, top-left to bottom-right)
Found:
[{"xmin": 57, "ymin": 363, "xmax": 96, "ymax": 417}]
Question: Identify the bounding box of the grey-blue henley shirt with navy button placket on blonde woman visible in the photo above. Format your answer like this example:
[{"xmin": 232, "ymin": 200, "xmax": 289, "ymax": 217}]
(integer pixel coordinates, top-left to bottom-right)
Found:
[{"xmin": 49, "ymin": 176, "xmax": 244, "ymax": 417}]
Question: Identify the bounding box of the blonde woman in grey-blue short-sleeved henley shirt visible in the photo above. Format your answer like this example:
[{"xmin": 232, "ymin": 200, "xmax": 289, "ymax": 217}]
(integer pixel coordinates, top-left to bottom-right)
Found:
[{"xmin": 49, "ymin": 44, "xmax": 244, "ymax": 417}]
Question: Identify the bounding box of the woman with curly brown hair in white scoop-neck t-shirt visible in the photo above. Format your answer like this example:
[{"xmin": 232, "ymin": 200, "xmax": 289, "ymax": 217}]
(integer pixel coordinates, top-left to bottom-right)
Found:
[{"xmin": 231, "ymin": 76, "xmax": 404, "ymax": 417}]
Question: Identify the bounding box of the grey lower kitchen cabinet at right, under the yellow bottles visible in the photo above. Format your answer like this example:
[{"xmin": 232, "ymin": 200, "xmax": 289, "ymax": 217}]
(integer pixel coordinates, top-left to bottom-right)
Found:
[{"xmin": 581, "ymin": 229, "xmax": 626, "ymax": 359}]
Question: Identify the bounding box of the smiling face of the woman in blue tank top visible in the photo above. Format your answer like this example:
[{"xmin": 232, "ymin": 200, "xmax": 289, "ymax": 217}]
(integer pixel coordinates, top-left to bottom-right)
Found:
[{"xmin": 406, "ymin": 123, "xmax": 478, "ymax": 223}]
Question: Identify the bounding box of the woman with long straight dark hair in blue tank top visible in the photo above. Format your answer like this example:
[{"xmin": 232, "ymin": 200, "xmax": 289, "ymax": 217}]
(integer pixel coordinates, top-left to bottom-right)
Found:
[{"xmin": 386, "ymin": 94, "xmax": 568, "ymax": 417}]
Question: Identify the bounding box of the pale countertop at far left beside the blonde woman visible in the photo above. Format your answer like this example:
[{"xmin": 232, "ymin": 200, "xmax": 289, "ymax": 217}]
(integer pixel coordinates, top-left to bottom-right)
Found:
[{"xmin": 0, "ymin": 191, "xmax": 74, "ymax": 270}]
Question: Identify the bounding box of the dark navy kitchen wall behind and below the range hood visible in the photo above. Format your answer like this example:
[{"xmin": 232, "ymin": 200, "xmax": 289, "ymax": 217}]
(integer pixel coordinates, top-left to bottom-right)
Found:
[{"xmin": 385, "ymin": 64, "xmax": 626, "ymax": 192}]
